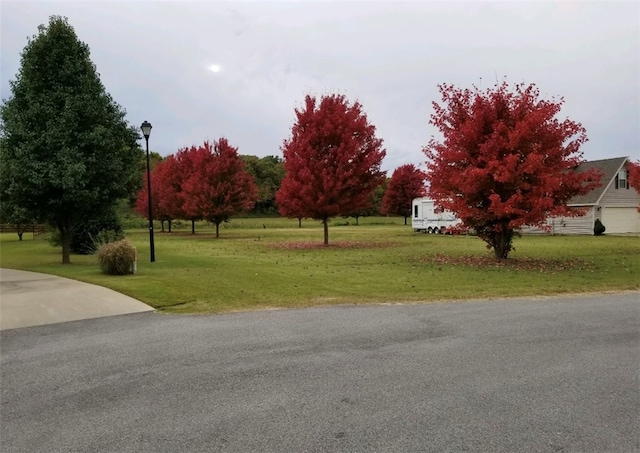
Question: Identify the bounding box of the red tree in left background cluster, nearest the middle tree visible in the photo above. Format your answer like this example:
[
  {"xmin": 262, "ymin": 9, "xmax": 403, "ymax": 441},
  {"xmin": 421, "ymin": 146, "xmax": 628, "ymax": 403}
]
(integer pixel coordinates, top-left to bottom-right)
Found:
[{"xmin": 182, "ymin": 137, "xmax": 258, "ymax": 237}]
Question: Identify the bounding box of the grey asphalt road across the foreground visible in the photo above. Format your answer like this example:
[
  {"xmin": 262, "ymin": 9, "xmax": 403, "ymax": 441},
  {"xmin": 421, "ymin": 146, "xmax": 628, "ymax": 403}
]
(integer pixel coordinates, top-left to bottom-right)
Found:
[{"xmin": 0, "ymin": 293, "xmax": 640, "ymax": 453}]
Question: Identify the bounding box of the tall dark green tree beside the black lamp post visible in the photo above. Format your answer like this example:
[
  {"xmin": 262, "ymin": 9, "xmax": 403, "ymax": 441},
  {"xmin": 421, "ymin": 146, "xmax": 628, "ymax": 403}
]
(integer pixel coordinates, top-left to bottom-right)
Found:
[{"xmin": 0, "ymin": 16, "xmax": 141, "ymax": 264}]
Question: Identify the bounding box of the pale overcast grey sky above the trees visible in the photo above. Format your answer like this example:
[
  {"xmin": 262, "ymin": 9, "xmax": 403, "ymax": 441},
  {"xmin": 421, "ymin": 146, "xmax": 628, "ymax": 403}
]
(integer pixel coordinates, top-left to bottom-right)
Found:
[{"xmin": 0, "ymin": 0, "xmax": 640, "ymax": 173}]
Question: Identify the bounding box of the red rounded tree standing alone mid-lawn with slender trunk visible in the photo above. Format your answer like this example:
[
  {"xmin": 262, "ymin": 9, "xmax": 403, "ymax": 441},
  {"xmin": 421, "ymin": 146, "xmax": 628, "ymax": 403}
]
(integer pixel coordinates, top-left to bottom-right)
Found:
[{"xmin": 276, "ymin": 94, "xmax": 386, "ymax": 245}]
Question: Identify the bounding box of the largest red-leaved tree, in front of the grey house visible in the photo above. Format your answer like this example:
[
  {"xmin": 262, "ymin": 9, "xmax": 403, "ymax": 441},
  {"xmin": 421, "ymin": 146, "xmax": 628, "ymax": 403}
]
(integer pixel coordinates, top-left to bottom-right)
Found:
[{"xmin": 424, "ymin": 82, "xmax": 601, "ymax": 259}]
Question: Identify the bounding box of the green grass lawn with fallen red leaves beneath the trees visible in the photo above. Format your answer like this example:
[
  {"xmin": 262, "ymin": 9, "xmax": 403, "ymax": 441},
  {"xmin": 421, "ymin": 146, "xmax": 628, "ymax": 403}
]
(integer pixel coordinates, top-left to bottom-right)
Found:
[{"xmin": 0, "ymin": 218, "xmax": 640, "ymax": 313}]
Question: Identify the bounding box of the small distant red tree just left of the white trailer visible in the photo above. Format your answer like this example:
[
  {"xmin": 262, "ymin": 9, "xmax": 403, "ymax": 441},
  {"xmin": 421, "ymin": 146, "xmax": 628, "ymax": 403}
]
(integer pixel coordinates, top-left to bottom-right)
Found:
[{"xmin": 382, "ymin": 164, "xmax": 427, "ymax": 225}]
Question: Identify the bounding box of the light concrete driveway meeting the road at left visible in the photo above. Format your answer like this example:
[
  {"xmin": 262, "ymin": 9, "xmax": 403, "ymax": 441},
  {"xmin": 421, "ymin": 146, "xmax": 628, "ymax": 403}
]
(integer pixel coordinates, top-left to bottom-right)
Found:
[{"xmin": 0, "ymin": 269, "xmax": 153, "ymax": 330}]
